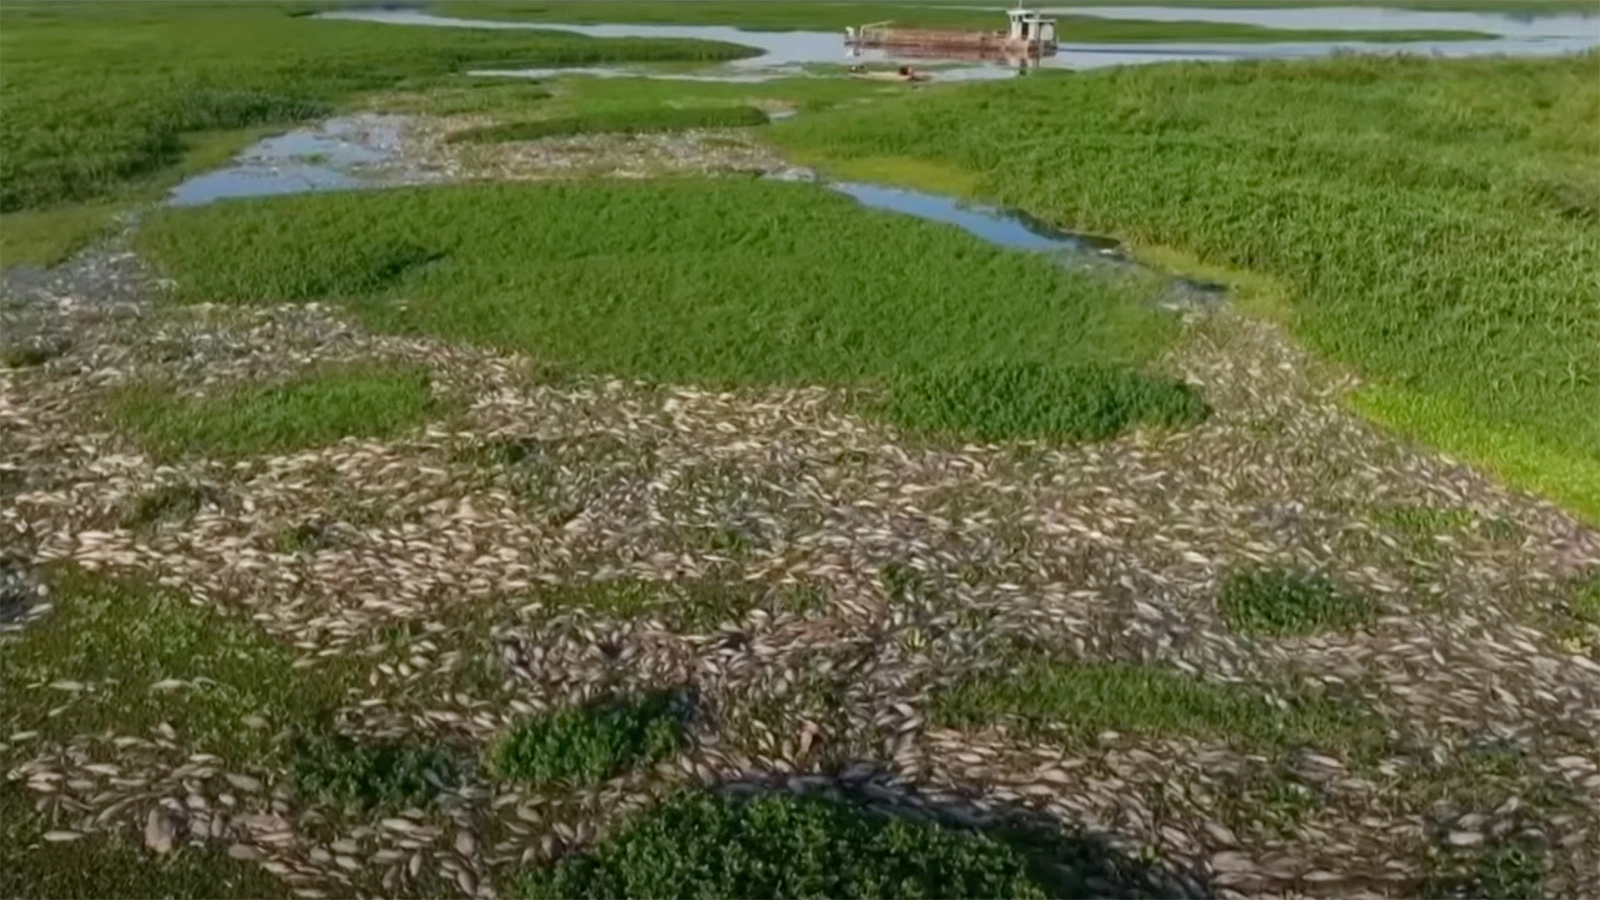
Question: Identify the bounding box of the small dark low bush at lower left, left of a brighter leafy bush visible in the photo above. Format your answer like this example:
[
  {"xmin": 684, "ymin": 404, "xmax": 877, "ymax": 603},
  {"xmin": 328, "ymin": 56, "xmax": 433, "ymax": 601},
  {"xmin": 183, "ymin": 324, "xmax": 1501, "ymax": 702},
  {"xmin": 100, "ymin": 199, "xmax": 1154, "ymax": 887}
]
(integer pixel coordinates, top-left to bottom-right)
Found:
[{"xmin": 291, "ymin": 730, "xmax": 462, "ymax": 809}]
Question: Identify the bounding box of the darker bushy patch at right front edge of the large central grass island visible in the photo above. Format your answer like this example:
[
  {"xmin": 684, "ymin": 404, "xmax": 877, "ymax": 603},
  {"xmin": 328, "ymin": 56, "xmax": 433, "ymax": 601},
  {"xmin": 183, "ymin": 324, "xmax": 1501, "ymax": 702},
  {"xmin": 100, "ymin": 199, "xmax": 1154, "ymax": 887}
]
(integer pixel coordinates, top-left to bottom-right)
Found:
[{"xmin": 890, "ymin": 364, "xmax": 1206, "ymax": 440}]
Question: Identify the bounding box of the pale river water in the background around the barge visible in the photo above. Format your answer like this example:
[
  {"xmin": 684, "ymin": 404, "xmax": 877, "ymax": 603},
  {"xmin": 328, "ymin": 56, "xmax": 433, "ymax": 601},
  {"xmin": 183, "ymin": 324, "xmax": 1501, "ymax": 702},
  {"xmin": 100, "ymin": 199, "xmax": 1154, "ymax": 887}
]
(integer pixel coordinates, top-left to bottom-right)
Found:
[{"xmin": 317, "ymin": 6, "xmax": 1600, "ymax": 80}]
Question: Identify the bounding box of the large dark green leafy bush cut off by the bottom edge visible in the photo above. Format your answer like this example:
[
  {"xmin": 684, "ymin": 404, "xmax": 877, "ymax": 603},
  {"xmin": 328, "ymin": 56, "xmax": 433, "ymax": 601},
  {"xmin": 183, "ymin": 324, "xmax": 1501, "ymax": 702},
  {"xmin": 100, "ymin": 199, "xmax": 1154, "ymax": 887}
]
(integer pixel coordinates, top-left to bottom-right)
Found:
[{"xmin": 514, "ymin": 794, "xmax": 1045, "ymax": 898}]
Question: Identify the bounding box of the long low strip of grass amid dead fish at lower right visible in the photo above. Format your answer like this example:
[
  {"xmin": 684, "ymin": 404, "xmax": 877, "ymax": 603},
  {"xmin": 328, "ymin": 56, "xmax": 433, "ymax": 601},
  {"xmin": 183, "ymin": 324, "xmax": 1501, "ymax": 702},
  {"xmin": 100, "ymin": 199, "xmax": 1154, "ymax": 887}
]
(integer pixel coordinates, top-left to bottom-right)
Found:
[{"xmin": 933, "ymin": 655, "xmax": 1382, "ymax": 757}]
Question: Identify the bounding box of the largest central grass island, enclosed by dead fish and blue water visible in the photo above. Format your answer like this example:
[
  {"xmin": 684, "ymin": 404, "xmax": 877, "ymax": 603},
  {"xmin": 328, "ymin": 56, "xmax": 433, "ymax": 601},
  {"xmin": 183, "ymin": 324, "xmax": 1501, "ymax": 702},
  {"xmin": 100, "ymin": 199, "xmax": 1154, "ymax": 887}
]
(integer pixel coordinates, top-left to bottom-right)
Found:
[{"xmin": 141, "ymin": 179, "xmax": 1173, "ymax": 441}]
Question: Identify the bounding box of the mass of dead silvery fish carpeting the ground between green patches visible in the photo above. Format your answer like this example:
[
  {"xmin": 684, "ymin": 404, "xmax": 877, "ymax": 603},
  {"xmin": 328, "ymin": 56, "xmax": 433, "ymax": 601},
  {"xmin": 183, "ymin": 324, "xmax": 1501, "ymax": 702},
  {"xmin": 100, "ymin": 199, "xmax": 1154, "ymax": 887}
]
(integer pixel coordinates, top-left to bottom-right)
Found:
[{"xmin": 0, "ymin": 209, "xmax": 1600, "ymax": 897}]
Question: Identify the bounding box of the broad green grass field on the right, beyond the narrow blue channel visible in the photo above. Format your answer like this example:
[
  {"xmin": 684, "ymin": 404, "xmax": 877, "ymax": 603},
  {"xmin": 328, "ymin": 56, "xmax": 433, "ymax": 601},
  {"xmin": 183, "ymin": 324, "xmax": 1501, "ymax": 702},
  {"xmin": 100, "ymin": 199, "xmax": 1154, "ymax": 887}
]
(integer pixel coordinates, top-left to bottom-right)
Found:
[{"xmin": 770, "ymin": 53, "xmax": 1600, "ymax": 520}]
